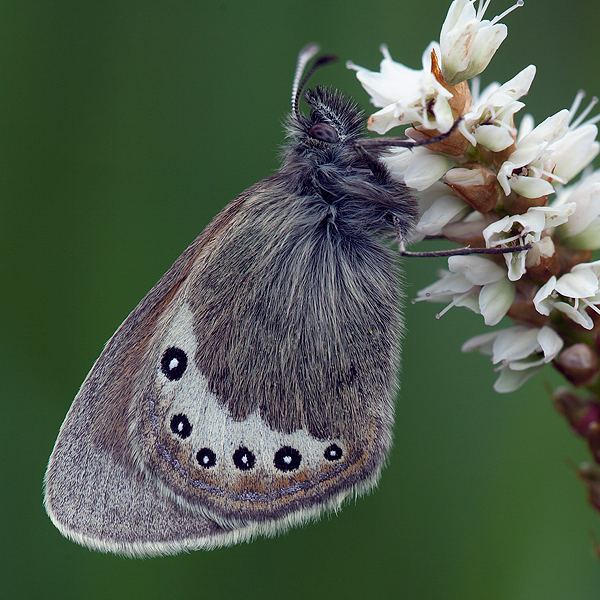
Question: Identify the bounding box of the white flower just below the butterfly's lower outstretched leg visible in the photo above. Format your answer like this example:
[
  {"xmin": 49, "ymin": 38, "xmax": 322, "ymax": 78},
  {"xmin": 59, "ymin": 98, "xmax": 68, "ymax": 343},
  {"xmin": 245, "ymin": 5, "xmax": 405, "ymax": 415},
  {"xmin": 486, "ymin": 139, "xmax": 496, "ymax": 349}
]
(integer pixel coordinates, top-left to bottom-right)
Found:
[{"xmin": 415, "ymin": 254, "xmax": 515, "ymax": 325}]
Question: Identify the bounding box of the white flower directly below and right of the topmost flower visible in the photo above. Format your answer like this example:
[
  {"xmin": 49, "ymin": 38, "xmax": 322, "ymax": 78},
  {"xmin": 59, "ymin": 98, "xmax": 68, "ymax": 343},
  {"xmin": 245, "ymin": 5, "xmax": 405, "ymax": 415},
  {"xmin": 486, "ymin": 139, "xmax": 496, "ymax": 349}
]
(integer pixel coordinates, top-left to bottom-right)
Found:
[{"xmin": 459, "ymin": 65, "xmax": 535, "ymax": 152}]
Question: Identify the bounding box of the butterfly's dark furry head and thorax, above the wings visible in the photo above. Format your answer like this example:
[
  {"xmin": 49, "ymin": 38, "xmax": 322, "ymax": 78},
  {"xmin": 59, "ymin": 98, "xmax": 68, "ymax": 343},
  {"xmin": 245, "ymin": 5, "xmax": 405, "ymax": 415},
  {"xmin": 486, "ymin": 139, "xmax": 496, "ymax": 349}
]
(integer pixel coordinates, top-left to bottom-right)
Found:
[{"xmin": 280, "ymin": 87, "xmax": 418, "ymax": 244}]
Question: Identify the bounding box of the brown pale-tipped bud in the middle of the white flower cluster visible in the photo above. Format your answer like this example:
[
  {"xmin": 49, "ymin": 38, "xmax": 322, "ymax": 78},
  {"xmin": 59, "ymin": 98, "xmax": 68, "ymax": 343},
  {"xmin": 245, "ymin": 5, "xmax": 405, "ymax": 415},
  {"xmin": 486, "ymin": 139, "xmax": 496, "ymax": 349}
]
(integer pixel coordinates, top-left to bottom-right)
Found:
[{"xmin": 444, "ymin": 164, "xmax": 501, "ymax": 213}]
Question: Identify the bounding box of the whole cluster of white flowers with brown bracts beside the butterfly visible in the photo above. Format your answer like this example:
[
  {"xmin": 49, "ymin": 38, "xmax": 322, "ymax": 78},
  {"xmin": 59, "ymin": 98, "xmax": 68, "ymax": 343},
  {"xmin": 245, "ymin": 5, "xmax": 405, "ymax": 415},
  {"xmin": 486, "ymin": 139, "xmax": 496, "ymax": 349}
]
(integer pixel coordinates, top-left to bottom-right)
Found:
[{"xmin": 348, "ymin": 0, "xmax": 600, "ymax": 392}]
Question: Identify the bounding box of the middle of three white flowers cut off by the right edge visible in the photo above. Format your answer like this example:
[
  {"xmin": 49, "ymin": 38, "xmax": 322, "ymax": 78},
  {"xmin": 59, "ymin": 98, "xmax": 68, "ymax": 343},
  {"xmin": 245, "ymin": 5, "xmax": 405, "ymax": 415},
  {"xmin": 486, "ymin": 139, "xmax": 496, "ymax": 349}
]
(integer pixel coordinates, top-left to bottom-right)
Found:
[{"xmin": 552, "ymin": 170, "xmax": 600, "ymax": 250}]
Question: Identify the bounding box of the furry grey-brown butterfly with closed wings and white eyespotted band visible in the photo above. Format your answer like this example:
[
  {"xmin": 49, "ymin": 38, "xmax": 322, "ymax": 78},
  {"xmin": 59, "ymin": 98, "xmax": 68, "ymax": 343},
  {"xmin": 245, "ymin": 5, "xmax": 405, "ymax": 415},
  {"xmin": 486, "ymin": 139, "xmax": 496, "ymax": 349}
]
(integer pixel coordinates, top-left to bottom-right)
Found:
[{"xmin": 45, "ymin": 88, "xmax": 417, "ymax": 555}]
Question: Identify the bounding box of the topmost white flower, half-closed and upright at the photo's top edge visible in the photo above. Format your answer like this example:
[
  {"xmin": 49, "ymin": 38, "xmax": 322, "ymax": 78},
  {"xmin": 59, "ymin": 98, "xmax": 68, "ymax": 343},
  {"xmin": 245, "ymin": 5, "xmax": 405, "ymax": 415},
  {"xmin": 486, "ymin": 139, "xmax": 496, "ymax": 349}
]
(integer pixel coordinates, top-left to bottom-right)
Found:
[{"xmin": 440, "ymin": 0, "xmax": 523, "ymax": 85}]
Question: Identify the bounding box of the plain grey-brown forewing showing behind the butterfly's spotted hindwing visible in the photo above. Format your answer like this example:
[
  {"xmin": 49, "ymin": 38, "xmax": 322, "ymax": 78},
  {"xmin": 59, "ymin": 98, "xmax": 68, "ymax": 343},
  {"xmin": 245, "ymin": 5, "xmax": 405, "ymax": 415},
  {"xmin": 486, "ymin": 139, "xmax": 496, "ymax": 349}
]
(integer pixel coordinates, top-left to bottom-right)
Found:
[{"xmin": 44, "ymin": 197, "xmax": 255, "ymax": 555}]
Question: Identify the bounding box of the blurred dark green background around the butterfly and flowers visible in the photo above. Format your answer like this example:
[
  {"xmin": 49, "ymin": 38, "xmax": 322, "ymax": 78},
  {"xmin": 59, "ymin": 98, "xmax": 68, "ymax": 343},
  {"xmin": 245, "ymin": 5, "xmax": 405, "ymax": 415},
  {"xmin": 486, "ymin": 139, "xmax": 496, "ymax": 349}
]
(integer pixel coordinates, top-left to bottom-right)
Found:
[{"xmin": 0, "ymin": 0, "xmax": 600, "ymax": 600}]
